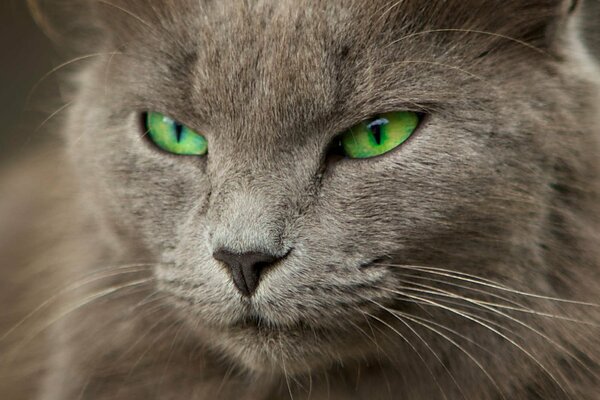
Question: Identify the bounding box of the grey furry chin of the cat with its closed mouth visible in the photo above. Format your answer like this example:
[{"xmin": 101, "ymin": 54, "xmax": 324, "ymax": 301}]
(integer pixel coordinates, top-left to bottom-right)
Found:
[{"xmin": 162, "ymin": 284, "xmax": 400, "ymax": 374}]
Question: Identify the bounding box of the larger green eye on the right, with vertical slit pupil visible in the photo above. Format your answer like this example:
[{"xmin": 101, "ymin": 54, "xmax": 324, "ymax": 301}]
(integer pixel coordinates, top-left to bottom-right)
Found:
[{"xmin": 340, "ymin": 111, "xmax": 420, "ymax": 158}]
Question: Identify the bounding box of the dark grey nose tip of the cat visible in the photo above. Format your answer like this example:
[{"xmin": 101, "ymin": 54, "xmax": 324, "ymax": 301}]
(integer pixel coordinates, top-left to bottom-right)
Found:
[{"xmin": 213, "ymin": 249, "xmax": 280, "ymax": 297}]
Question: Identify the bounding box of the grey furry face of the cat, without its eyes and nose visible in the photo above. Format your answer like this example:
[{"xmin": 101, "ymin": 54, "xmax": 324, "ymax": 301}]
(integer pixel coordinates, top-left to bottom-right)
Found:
[{"xmin": 64, "ymin": 0, "xmax": 592, "ymax": 370}]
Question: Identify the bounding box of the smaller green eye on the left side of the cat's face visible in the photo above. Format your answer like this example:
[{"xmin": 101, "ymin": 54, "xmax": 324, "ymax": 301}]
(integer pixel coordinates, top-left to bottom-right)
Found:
[{"xmin": 146, "ymin": 112, "xmax": 208, "ymax": 156}]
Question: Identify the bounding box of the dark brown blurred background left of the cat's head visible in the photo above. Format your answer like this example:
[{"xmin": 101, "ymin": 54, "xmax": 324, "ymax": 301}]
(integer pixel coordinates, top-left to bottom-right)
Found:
[{"xmin": 0, "ymin": 0, "xmax": 56, "ymax": 166}]
